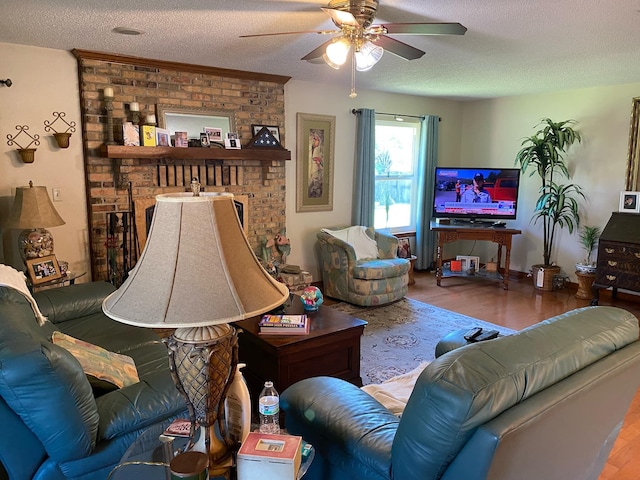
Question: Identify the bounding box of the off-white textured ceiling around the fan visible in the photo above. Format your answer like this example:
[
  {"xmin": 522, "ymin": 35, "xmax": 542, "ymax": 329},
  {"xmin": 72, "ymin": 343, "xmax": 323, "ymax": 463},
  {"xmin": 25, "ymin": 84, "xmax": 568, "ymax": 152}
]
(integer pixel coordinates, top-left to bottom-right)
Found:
[{"xmin": 0, "ymin": 0, "xmax": 640, "ymax": 99}]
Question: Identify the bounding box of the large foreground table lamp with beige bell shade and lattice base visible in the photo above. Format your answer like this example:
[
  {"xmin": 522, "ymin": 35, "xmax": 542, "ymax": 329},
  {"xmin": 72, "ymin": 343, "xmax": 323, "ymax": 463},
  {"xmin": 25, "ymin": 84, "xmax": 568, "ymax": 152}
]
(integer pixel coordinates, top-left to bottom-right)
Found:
[{"xmin": 102, "ymin": 188, "xmax": 289, "ymax": 471}]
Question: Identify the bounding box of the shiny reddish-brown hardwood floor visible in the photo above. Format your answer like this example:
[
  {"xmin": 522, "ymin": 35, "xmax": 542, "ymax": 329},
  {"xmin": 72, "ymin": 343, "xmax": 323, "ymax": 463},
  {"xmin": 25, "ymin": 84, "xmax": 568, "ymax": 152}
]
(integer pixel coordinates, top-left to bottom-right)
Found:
[{"xmin": 407, "ymin": 272, "xmax": 640, "ymax": 480}]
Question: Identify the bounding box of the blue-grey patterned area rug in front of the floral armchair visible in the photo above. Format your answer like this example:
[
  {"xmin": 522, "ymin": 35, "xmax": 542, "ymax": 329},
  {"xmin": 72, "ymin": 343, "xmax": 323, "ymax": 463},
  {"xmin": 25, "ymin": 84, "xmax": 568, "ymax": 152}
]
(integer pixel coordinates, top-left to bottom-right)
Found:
[{"xmin": 330, "ymin": 298, "xmax": 514, "ymax": 385}]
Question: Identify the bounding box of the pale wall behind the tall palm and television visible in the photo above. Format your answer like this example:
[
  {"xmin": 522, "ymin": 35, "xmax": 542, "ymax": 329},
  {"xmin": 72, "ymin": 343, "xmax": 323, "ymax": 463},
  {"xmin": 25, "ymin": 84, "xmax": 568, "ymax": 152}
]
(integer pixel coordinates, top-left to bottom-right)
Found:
[{"xmin": 460, "ymin": 84, "xmax": 640, "ymax": 282}]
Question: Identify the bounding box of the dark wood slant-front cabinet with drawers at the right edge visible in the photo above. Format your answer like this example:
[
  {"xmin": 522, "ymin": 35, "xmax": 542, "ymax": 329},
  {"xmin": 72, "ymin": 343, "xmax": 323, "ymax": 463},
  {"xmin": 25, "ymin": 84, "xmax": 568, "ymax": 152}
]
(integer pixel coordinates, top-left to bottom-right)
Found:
[{"xmin": 592, "ymin": 212, "xmax": 640, "ymax": 305}]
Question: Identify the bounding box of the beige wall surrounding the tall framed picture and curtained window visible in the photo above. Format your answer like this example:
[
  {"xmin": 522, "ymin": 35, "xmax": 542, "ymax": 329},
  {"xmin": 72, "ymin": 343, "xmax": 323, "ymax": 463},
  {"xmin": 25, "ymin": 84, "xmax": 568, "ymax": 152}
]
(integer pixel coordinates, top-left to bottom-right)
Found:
[{"xmin": 285, "ymin": 81, "xmax": 462, "ymax": 279}]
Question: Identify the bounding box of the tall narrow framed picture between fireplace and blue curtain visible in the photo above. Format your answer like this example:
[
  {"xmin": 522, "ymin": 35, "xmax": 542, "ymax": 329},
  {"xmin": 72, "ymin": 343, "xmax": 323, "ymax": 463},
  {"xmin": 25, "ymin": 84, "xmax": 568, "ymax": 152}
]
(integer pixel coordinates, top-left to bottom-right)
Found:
[{"xmin": 296, "ymin": 113, "xmax": 336, "ymax": 212}]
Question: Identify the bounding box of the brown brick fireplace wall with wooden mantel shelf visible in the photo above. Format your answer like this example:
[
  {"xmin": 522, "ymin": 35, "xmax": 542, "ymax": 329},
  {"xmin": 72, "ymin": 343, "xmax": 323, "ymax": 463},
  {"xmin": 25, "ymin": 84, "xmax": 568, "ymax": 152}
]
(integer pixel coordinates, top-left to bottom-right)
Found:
[{"xmin": 73, "ymin": 50, "xmax": 289, "ymax": 280}]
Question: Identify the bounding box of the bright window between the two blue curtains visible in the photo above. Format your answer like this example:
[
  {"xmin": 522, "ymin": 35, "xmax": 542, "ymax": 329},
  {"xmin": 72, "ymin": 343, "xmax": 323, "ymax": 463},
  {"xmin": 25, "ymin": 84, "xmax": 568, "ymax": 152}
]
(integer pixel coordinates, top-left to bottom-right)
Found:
[{"xmin": 374, "ymin": 118, "xmax": 420, "ymax": 232}]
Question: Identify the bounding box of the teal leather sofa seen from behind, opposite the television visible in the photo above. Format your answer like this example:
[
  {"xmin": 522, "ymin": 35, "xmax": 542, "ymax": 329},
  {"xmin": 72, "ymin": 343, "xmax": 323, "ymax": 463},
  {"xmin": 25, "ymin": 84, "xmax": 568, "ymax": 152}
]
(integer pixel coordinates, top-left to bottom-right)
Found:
[{"xmin": 281, "ymin": 307, "xmax": 640, "ymax": 480}]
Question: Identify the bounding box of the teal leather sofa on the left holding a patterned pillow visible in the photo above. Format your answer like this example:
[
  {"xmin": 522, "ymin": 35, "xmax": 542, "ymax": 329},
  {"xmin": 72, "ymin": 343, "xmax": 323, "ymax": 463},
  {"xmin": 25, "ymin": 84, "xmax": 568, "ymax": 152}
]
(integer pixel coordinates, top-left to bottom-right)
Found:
[{"xmin": 0, "ymin": 282, "xmax": 187, "ymax": 480}]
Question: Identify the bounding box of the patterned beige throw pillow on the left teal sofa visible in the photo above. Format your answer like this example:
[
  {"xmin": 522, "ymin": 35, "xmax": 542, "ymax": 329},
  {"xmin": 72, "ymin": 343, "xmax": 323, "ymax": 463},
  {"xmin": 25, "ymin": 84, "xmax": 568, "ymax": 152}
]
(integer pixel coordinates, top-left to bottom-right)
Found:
[{"xmin": 51, "ymin": 332, "xmax": 140, "ymax": 390}]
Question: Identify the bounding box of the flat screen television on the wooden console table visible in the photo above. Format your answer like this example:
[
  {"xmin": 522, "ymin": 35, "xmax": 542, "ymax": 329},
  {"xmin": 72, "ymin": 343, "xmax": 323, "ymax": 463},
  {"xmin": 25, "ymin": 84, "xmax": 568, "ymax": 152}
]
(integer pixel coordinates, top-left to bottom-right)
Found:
[{"xmin": 433, "ymin": 167, "xmax": 520, "ymax": 222}]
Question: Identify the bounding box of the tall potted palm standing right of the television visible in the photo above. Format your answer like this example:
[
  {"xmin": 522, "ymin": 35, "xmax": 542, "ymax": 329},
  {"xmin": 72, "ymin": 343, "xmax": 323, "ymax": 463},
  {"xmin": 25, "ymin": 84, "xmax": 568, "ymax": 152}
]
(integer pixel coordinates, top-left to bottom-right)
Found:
[{"xmin": 515, "ymin": 118, "xmax": 584, "ymax": 290}]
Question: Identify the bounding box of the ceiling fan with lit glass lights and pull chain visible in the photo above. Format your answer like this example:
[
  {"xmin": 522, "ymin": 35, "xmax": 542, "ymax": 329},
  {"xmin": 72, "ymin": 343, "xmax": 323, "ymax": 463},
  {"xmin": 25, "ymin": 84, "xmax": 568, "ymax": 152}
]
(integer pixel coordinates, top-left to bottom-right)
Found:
[{"xmin": 240, "ymin": 0, "xmax": 467, "ymax": 97}]
